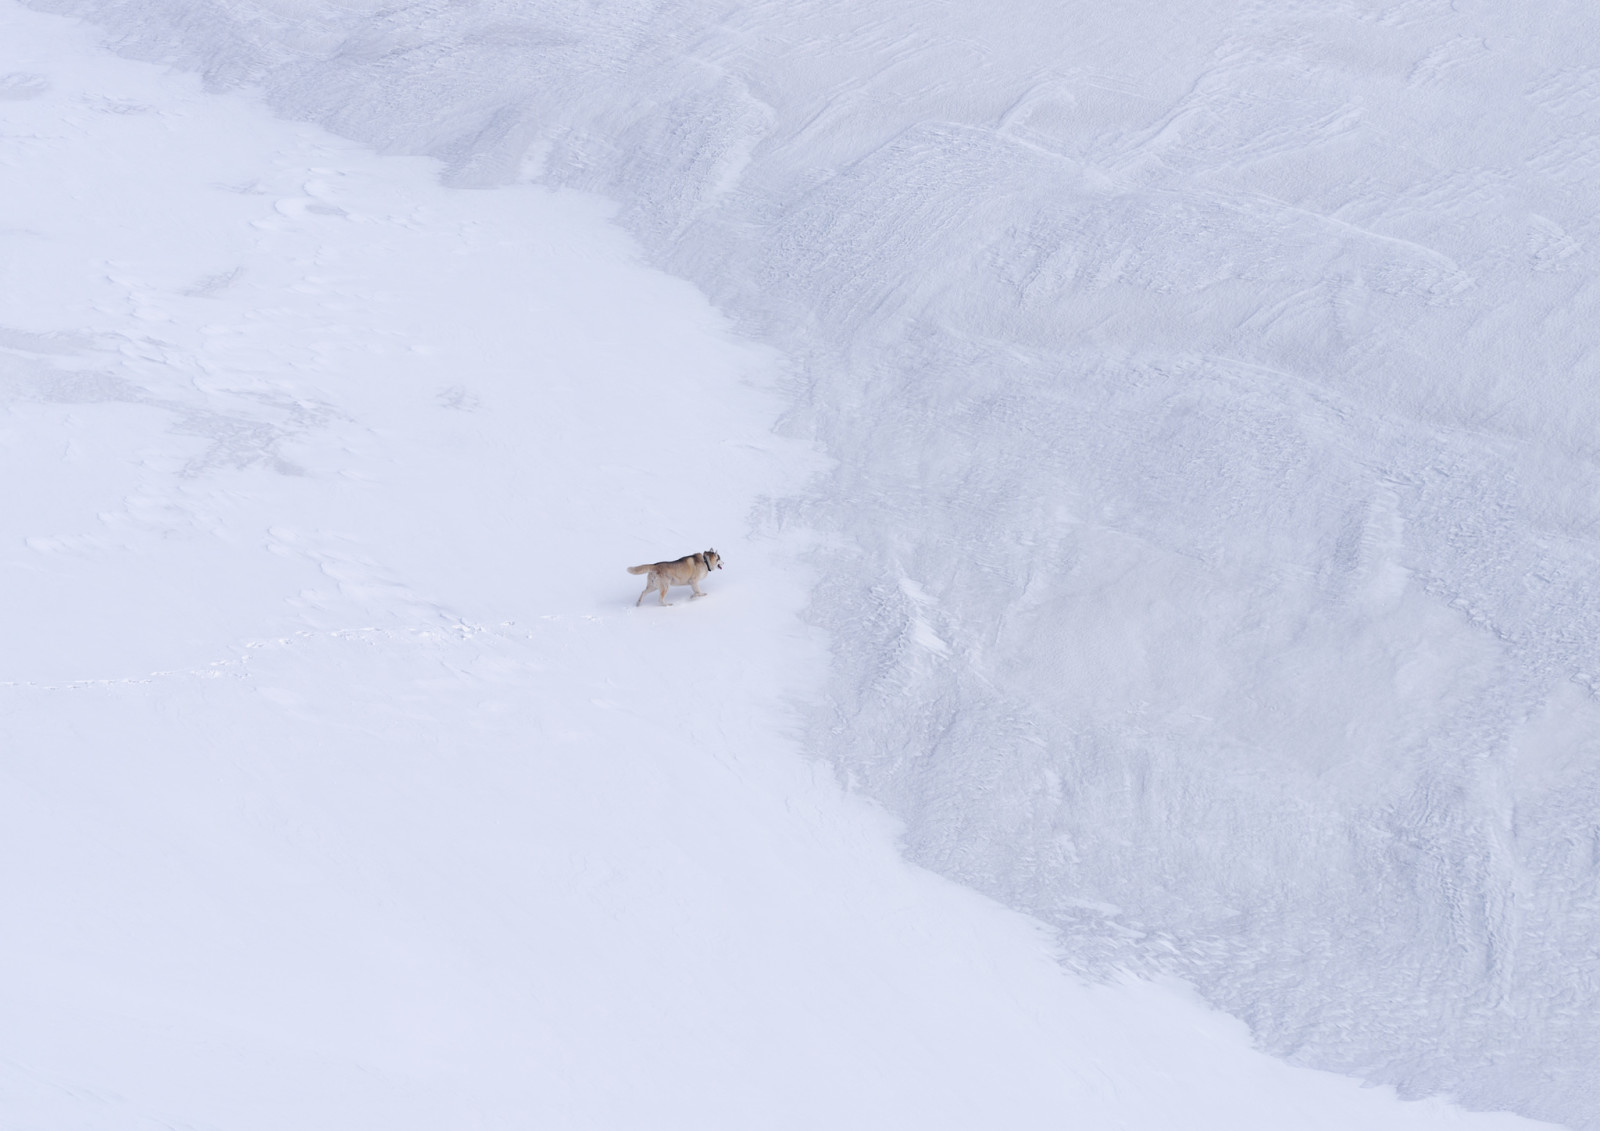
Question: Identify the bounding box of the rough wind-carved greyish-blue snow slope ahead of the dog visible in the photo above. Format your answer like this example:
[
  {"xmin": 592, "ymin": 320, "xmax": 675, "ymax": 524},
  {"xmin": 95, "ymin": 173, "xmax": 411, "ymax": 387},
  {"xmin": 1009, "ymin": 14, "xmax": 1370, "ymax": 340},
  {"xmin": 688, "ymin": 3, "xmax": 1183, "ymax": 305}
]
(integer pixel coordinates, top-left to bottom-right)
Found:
[{"xmin": 28, "ymin": 0, "xmax": 1600, "ymax": 1128}]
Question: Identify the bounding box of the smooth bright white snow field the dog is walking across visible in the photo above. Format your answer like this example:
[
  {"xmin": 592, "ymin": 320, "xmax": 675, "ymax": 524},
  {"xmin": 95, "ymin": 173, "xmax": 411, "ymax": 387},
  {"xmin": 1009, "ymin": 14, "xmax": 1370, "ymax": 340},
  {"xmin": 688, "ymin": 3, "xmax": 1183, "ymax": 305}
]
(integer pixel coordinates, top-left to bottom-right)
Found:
[{"xmin": 0, "ymin": 3, "xmax": 1580, "ymax": 1131}]
